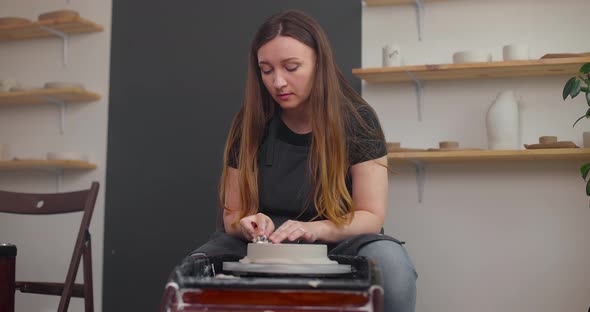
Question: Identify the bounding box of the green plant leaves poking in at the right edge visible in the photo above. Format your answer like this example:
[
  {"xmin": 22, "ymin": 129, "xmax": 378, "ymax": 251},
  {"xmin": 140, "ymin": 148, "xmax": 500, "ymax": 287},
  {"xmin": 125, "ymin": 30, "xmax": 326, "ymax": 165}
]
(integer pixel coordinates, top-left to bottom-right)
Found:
[{"xmin": 563, "ymin": 63, "xmax": 590, "ymax": 196}]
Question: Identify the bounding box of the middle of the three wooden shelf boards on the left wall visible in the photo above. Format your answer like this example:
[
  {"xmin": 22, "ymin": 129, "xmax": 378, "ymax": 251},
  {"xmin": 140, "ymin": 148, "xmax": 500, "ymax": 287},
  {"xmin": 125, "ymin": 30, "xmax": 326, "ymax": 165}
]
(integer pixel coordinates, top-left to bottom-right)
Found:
[{"xmin": 0, "ymin": 88, "xmax": 100, "ymax": 105}]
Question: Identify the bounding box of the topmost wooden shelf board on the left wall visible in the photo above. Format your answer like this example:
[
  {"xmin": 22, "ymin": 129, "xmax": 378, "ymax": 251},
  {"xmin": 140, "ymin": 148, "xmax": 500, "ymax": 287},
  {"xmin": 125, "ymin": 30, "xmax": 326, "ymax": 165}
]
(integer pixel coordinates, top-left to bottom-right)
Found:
[{"xmin": 0, "ymin": 17, "xmax": 103, "ymax": 41}]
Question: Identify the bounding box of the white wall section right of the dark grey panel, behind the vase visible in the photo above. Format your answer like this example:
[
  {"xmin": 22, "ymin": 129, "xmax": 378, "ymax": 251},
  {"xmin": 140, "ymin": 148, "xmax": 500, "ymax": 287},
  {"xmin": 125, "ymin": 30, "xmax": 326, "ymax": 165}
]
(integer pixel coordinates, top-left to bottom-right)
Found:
[{"xmin": 362, "ymin": 0, "xmax": 590, "ymax": 312}]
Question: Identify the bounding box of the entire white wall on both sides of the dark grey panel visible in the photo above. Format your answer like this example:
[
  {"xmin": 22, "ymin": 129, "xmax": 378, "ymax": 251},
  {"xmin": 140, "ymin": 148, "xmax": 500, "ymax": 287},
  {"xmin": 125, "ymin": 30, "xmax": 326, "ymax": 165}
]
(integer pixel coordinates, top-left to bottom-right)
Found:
[{"xmin": 0, "ymin": 0, "xmax": 590, "ymax": 312}]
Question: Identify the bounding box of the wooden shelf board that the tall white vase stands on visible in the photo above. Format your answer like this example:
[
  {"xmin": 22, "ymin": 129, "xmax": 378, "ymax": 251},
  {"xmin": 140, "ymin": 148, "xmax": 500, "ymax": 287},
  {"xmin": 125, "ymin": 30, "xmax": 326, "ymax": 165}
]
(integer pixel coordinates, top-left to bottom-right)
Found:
[{"xmin": 387, "ymin": 148, "xmax": 590, "ymax": 163}]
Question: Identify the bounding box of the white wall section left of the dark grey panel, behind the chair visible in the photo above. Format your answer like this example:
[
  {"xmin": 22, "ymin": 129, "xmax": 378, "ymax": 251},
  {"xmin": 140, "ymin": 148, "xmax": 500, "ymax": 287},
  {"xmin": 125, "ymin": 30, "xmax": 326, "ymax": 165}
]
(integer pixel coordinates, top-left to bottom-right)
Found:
[{"xmin": 0, "ymin": 0, "xmax": 112, "ymax": 311}]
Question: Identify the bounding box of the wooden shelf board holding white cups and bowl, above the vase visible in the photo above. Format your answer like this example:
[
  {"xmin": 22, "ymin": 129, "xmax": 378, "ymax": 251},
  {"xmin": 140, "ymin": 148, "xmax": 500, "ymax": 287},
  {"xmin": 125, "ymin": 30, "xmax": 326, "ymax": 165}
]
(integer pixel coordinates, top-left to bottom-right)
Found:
[{"xmin": 352, "ymin": 57, "xmax": 590, "ymax": 83}]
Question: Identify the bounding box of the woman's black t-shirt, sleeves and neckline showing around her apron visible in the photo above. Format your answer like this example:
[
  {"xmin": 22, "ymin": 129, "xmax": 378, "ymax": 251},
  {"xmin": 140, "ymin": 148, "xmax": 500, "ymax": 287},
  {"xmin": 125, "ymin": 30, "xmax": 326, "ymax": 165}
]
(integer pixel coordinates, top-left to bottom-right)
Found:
[{"xmin": 228, "ymin": 105, "xmax": 387, "ymax": 168}]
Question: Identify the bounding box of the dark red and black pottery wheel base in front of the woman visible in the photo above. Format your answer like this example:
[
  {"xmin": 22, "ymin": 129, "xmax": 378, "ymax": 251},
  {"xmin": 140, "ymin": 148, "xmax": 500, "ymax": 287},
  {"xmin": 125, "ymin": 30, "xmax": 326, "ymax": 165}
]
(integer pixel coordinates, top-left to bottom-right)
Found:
[{"xmin": 160, "ymin": 256, "xmax": 383, "ymax": 312}]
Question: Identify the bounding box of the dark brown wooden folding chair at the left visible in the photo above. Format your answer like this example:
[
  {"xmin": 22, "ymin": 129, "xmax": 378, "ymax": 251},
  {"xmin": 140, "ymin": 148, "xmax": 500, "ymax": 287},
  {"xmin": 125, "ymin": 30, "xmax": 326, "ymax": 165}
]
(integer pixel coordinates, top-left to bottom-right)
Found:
[{"xmin": 0, "ymin": 182, "xmax": 99, "ymax": 312}]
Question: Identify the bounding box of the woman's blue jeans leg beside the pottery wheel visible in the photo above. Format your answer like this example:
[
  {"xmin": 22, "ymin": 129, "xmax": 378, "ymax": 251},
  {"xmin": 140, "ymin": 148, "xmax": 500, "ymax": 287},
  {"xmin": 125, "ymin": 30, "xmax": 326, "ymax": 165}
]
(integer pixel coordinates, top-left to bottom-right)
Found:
[{"xmin": 358, "ymin": 240, "xmax": 418, "ymax": 312}]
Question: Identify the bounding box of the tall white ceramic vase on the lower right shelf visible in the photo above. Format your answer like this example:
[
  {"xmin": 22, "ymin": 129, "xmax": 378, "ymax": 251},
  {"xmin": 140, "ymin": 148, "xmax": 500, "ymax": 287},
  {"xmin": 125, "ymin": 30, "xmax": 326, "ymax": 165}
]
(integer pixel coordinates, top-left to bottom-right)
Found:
[{"xmin": 486, "ymin": 90, "xmax": 520, "ymax": 150}]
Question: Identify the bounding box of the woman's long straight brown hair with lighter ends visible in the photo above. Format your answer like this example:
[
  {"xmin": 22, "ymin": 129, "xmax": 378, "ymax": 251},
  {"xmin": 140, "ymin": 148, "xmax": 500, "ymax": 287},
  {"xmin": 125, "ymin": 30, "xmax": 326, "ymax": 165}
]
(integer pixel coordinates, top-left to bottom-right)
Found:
[{"xmin": 219, "ymin": 10, "xmax": 383, "ymax": 226}]
